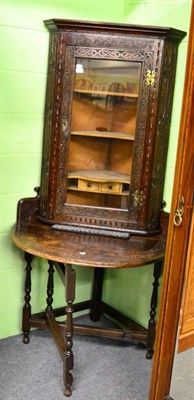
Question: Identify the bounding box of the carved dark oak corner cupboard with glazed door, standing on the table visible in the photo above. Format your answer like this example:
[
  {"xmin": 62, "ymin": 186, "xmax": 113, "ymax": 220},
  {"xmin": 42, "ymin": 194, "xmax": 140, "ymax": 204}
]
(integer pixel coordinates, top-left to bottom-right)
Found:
[{"xmin": 39, "ymin": 20, "xmax": 185, "ymax": 237}]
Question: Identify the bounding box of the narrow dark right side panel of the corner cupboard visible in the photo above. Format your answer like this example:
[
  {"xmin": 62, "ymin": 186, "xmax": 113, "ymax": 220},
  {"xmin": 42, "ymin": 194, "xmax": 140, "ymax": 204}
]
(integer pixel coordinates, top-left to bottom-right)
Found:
[{"xmin": 147, "ymin": 41, "xmax": 180, "ymax": 229}]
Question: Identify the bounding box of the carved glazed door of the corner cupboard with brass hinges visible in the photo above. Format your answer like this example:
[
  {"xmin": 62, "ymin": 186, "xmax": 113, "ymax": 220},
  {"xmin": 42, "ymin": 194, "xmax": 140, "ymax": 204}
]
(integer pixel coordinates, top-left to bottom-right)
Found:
[{"xmin": 55, "ymin": 47, "xmax": 155, "ymax": 233}]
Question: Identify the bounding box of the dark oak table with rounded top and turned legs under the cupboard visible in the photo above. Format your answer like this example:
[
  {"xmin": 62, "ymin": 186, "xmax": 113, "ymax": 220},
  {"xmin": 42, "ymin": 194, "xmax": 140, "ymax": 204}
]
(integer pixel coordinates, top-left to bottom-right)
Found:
[{"xmin": 11, "ymin": 213, "xmax": 168, "ymax": 396}]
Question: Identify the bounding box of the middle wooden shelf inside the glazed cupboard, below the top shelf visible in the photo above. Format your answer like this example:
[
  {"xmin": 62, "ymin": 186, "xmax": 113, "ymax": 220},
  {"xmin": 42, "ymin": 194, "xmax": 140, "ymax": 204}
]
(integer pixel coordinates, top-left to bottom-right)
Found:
[{"xmin": 71, "ymin": 131, "xmax": 135, "ymax": 141}]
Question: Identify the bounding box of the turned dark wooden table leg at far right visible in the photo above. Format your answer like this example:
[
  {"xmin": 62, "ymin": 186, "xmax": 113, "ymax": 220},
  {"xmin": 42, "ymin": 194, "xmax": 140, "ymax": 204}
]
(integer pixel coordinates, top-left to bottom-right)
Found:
[{"xmin": 146, "ymin": 260, "xmax": 163, "ymax": 359}]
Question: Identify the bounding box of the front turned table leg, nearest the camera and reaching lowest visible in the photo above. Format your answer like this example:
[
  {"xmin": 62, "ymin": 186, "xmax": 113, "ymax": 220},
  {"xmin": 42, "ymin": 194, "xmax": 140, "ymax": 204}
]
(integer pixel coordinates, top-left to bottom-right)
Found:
[{"xmin": 64, "ymin": 265, "xmax": 75, "ymax": 397}]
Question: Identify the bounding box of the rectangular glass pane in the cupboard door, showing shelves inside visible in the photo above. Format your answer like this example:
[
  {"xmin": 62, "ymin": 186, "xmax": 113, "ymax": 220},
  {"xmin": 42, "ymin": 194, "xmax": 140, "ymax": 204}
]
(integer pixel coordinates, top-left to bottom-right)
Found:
[{"xmin": 67, "ymin": 59, "xmax": 141, "ymax": 209}]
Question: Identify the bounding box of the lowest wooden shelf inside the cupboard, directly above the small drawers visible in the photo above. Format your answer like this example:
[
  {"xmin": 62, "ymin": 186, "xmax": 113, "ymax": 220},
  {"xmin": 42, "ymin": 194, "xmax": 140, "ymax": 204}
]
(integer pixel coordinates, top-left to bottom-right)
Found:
[{"xmin": 68, "ymin": 169, "xmax": 131, "ymax": 184}]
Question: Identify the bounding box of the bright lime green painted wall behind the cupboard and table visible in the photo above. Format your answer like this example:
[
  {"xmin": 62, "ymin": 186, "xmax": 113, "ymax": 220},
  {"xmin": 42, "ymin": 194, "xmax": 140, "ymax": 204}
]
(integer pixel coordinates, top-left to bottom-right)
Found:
[{"xmin": 0, "ymin": 0, "xmax": 191, "ymax": 338}]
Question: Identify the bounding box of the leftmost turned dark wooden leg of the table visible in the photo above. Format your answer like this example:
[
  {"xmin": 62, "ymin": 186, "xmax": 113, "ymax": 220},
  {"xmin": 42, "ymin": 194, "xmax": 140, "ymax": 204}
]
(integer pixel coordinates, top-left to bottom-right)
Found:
[{"xmin": 22, "ymin": 252, "xmax": 33, "ymax": 344}]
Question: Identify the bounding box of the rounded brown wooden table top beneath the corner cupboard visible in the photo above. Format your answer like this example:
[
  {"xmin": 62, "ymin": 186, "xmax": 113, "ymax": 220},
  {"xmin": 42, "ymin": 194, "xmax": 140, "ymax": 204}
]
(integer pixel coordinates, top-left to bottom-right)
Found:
[{"xmin": 11, "ymin": 216, "xmax": 166, "ymax": 268}]
